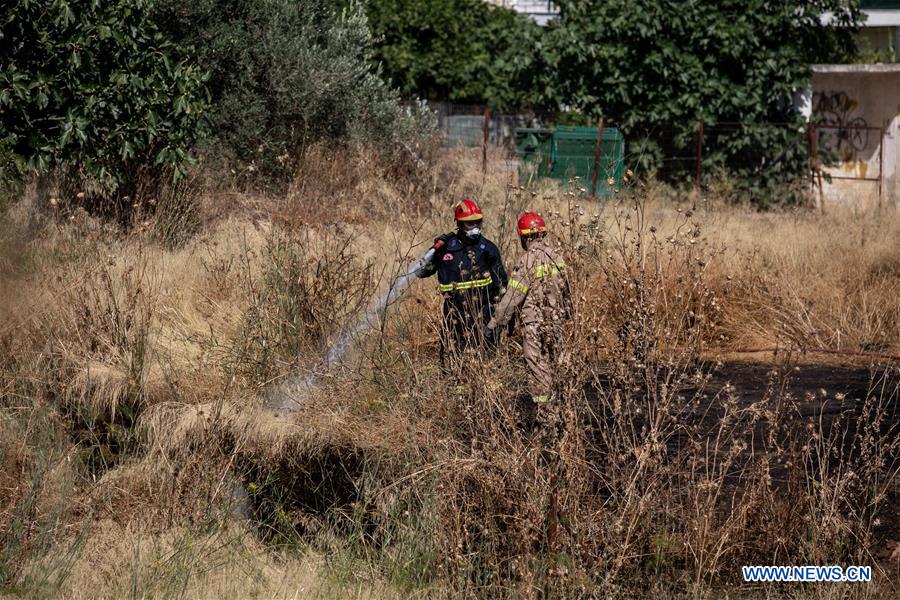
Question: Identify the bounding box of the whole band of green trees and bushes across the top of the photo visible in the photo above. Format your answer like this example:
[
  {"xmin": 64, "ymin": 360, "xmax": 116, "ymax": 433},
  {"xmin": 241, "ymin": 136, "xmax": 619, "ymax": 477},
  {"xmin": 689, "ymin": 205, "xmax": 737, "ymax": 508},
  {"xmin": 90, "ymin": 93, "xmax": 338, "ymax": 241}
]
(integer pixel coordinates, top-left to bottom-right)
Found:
[{"xmin": 0, "ymin": 0, "xmax": 860, "ymax": 204}]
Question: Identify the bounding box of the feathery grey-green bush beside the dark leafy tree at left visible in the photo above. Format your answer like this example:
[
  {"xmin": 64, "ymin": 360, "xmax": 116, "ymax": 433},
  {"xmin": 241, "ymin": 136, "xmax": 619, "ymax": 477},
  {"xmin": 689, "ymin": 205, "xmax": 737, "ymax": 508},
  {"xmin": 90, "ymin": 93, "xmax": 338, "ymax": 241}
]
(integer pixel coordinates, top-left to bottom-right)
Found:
[{"xmin": 156, "ymin": 0, "xmax": 436, "ymax": 185}]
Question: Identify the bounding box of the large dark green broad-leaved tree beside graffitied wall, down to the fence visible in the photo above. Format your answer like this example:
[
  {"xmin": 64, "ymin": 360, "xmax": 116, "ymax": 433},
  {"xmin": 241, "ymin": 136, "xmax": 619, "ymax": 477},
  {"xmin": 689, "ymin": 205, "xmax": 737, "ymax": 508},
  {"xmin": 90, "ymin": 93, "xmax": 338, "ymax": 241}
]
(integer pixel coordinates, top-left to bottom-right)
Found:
[{"xmin": 537, "ymin": 0, "xmax": 860, "ymax": 200}]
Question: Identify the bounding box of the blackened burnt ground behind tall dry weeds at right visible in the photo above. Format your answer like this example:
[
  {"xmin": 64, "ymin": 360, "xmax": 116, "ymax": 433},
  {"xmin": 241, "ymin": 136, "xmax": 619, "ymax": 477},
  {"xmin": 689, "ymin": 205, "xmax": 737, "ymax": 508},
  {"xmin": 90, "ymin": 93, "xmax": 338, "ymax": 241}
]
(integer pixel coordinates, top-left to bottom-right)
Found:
[{"xmin": 576, "ymin": 360, "xmax": 900, "ymax": 572}]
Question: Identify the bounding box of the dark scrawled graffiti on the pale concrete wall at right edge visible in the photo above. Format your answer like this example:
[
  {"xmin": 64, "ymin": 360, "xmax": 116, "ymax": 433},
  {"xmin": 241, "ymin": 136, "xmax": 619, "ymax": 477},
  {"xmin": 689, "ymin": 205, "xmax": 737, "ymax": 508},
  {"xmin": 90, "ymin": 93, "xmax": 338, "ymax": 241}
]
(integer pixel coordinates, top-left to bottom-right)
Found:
[{"xmin": 813, "ymin": 91, "xmax": 870, "ymax": 162}]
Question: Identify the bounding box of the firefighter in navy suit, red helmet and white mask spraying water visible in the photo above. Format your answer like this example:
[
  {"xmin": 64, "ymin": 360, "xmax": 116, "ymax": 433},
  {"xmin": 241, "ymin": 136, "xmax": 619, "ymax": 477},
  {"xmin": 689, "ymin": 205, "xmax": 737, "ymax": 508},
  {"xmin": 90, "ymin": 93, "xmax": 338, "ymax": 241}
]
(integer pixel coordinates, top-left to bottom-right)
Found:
[{"xmin": 417, "ymin": 198, "xmax": 507, "ymax": 356}]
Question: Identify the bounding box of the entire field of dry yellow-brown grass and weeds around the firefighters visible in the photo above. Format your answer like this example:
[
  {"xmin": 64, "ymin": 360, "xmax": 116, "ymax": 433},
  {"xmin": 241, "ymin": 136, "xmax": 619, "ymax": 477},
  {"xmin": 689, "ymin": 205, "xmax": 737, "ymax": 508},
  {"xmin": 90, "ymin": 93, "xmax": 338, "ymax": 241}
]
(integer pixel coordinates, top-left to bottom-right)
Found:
[{"xmin": 0, "ymin": 149, "xmax": 900, "ymax": 597}]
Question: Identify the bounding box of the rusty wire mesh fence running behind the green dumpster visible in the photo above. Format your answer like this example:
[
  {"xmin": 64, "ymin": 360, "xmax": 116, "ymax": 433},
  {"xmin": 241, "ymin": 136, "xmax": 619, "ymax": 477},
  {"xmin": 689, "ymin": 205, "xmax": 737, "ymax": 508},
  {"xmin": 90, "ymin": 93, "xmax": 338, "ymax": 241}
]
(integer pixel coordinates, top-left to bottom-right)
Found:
[{"xmin": 430, "ymin": 103, "xmax": 885, "ymax": 196}]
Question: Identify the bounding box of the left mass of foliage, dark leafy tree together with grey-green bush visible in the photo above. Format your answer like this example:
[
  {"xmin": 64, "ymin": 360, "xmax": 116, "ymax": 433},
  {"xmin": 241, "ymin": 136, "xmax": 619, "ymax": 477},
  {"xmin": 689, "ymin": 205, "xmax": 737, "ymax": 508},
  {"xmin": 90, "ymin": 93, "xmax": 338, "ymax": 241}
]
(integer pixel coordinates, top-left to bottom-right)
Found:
[{"xmin": 0, "ymin": 0, "xmax": 431, "ymax": 195}]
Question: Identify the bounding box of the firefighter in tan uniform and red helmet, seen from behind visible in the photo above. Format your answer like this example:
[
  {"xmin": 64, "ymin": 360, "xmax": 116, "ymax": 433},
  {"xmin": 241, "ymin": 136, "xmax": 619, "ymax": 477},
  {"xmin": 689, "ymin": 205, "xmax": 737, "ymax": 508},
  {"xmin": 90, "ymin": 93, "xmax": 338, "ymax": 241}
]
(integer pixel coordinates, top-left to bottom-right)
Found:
[{"xmin": 487, "ymin": 212, "xmax": 571, "ymax": 403}]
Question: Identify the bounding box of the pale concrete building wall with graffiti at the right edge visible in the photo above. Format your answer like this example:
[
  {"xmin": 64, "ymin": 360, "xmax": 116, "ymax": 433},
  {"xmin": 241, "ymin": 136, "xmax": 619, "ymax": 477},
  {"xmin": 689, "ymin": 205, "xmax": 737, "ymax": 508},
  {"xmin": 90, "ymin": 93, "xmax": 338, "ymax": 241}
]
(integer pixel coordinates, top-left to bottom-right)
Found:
[{"xmin": 801, "ymin": 64, "xmax": 900, "ymax": 206}]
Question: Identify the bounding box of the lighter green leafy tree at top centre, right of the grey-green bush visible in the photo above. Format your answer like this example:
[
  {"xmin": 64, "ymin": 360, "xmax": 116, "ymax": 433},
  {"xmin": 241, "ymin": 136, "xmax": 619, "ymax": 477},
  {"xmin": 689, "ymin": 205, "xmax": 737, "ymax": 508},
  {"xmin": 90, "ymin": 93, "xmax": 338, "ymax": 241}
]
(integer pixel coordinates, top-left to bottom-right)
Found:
[{"xmin": 367, "ymin": 0, "xmax": 540, "ymax": 110}]
